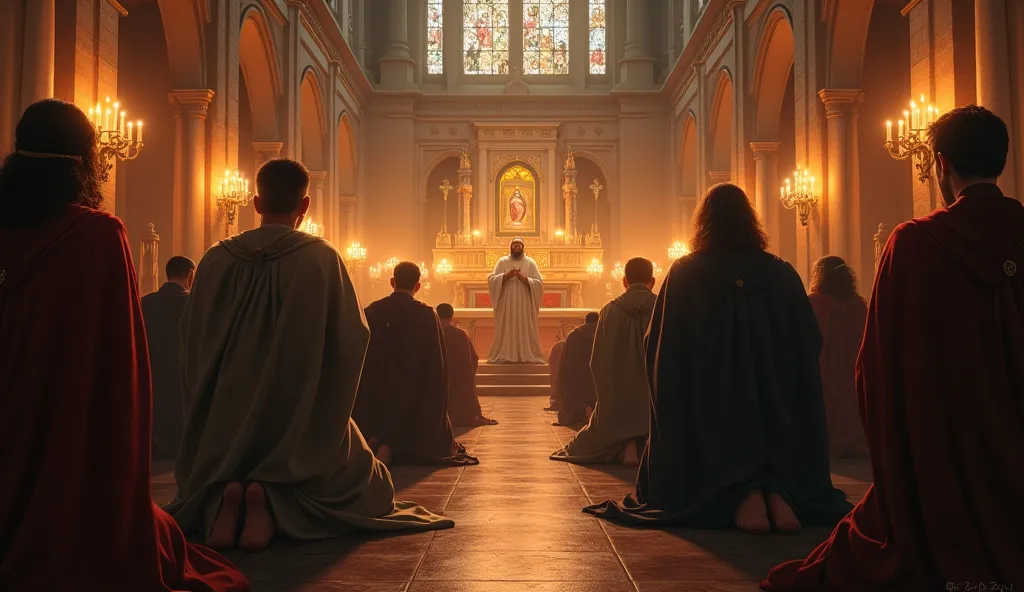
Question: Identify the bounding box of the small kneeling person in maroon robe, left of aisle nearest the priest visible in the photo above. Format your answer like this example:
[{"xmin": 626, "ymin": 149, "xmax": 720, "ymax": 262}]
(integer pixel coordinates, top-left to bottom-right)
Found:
[{"xmin": 436, "ymin": 302, "xmax": 498, "ymax": 427}]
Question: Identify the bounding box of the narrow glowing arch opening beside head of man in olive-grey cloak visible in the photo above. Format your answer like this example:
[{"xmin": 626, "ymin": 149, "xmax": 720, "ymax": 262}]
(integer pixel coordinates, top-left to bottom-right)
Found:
[{"xmin": 299, "ymin": 68, "xmax": 325, "ymax": 225}]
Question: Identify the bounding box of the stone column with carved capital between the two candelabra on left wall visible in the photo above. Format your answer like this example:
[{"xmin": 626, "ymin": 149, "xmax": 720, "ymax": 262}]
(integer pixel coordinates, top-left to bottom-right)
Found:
[{"xmin": 167, "ymin": 89, "xmax": 213, "ymax": 261}]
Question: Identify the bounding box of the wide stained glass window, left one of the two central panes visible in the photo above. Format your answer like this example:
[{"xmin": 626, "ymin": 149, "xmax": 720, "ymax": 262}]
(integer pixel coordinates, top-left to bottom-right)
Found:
[{"xmin": 462, "ymin": 0, "xmax": 509, "ymax": 74}]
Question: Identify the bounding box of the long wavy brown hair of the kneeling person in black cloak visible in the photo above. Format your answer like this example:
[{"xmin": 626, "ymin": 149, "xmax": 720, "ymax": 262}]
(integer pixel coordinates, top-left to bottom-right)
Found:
[{"xmin": 690, "ymin": 183, "xmax": 768, "ymax": 253}]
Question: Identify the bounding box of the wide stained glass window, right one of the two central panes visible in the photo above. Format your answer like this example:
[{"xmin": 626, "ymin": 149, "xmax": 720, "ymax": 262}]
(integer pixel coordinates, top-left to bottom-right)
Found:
[{"xmin": 522, "ymin": 0, "xmax": 569, "ymax": 74}]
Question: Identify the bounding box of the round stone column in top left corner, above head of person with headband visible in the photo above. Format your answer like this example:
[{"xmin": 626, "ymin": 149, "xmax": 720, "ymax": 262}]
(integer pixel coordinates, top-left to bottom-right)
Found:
[{"xmin": 22, "ymin": 0, "xmax": 56, "ymax": 111}]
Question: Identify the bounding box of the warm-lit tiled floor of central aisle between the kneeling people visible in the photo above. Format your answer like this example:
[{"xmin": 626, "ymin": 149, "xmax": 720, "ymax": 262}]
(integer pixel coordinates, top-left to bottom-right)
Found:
[{"xmin": 154, "ymin": 397, "xmax": 870, "ymax": 592}]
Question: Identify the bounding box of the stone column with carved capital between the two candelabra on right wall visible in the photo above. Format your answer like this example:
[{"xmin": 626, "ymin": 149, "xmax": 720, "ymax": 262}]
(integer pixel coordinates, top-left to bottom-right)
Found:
[{"xmin": 812, "ymin": 89, "xmax": 870, "ymax": 278}]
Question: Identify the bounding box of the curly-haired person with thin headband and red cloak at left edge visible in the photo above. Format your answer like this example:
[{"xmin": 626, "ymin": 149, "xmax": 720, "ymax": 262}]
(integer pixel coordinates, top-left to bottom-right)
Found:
[{"xmin": 0, "ymin": 99, "xmax": 249, "ymax": 592}]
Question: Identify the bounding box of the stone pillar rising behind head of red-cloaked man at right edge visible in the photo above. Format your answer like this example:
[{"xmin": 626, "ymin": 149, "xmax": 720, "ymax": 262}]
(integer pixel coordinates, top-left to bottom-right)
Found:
[{"xmin": 974, "ymin": 0, "xmax": 1024, "ymax": 197}]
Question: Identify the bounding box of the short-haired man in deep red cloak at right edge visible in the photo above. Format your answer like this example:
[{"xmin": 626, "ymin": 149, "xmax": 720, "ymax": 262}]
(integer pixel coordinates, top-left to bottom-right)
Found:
[{"xmin": 761, "ymin": 105, "xmax": 1024, "ymax": 592}]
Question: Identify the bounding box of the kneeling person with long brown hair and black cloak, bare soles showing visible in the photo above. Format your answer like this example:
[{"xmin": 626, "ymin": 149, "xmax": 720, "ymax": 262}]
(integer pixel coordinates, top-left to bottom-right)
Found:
[{"xmin": 585, "ymin": 184, "xmax": 852, "ymax": 533}]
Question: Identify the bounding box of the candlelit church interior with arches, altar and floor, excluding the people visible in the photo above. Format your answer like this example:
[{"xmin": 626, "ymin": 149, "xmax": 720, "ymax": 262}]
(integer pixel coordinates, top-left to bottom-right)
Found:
[{"xmin": 0, "ymin": 0, "xmax": 1024, "ymax": 592}]
